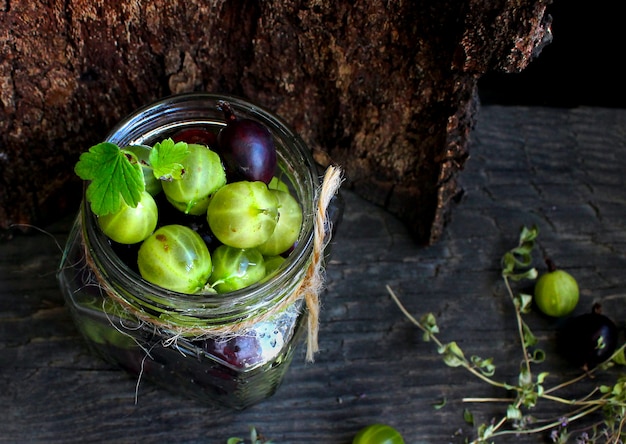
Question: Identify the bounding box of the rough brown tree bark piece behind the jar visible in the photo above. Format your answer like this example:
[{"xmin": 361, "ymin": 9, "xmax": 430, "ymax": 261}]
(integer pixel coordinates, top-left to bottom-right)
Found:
[{"xmin": 0, "ymin": 0, "xmax": 550, "ymax": 243}]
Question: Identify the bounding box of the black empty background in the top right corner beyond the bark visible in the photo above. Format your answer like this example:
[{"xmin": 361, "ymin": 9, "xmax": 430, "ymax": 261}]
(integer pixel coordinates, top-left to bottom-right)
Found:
[{"xmin": 479, "ymin": 0, "xmax": 626, "ymax": 108}]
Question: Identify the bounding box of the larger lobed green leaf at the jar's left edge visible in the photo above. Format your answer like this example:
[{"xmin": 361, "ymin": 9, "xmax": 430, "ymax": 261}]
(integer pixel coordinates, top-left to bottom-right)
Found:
[{"xmin": 74, "ymin": 142, "xmax": 145, "ymax": 216}]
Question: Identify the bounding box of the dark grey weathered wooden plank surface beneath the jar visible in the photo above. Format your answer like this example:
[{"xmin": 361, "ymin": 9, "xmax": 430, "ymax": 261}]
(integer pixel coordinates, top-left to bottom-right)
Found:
[{"xmin": 0, "ymin": 106, "xmax": 626, "ymax": 444}]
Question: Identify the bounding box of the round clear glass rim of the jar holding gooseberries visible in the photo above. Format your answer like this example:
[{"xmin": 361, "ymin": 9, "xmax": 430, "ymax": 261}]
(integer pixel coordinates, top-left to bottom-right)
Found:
[{"xmin": 82, "ymin": 92, "xmax": 319, "ymax": 317}]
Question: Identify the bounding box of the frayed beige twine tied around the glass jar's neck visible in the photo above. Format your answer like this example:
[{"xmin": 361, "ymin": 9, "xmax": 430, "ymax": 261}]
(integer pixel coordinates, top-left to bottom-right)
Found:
[{"xmin": 83, "ymin": 165, "xmax": 343, "ymax": 362}]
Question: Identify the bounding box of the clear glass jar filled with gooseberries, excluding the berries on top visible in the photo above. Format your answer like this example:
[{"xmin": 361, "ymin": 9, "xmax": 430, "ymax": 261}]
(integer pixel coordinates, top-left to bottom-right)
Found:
[{"xmin": 58, "ymin": 93, "xmax": 341, "ymax": 409}]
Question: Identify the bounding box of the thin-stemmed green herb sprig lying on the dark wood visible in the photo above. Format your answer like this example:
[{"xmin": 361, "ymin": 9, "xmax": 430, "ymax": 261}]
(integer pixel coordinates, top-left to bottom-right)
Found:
[{"xmin": 387, "ymin": 227, "xmax": 626, "ymax": 444}]
